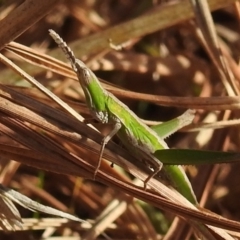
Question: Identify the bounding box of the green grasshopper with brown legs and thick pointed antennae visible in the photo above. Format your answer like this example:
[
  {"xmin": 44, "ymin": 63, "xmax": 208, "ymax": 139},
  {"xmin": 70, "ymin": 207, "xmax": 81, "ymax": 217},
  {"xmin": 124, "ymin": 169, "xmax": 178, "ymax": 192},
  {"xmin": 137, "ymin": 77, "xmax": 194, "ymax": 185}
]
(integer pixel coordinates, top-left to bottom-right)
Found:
[{"xmin": 49, "ymin": 30, "xmax": 197, "ymax": 204}]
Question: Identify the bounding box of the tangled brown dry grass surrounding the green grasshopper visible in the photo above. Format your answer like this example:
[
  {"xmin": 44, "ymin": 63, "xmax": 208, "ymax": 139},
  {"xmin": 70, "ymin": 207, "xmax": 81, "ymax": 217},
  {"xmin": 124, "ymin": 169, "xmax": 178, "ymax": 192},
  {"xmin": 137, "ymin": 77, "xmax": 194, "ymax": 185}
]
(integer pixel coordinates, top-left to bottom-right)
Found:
[{"xmin": 0, "ymin": 0, "xmax": 240, "ymax": 240}]
